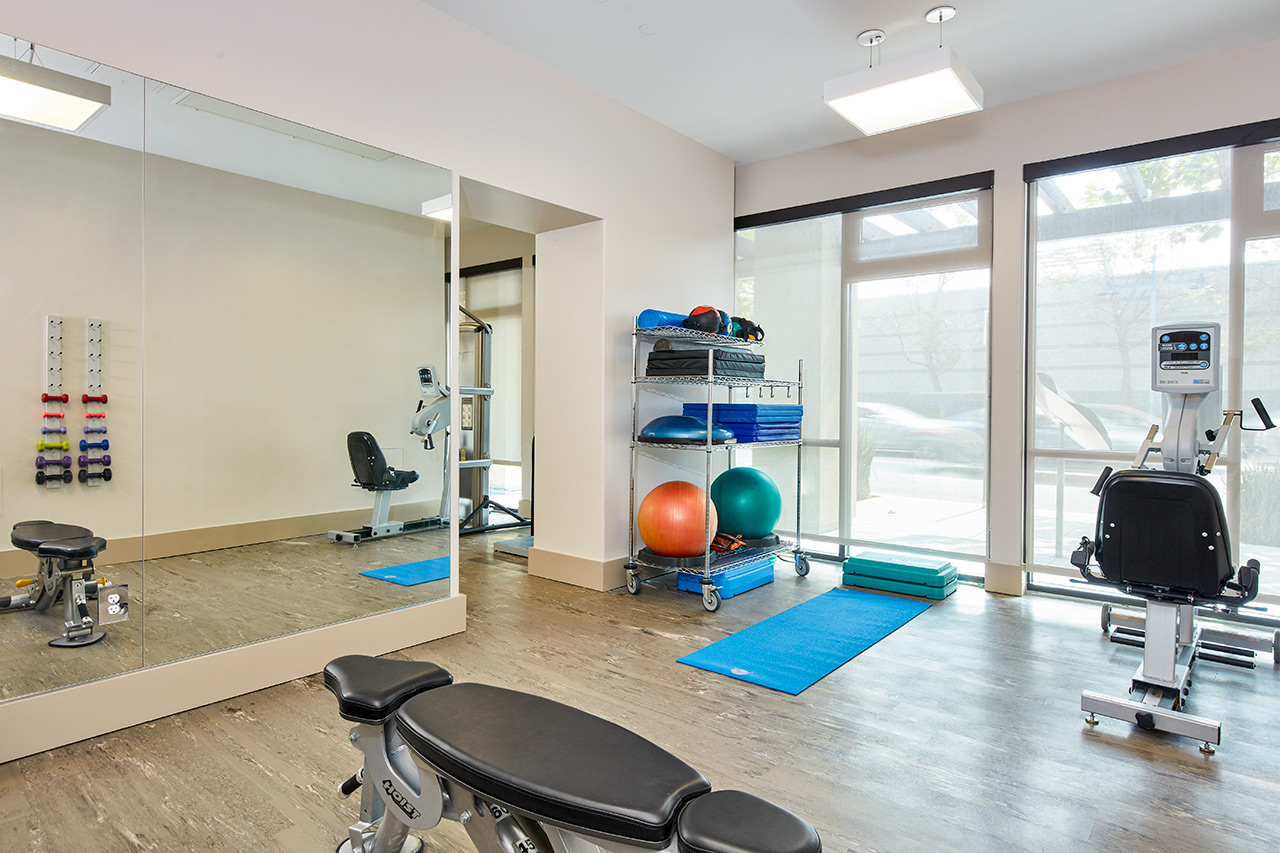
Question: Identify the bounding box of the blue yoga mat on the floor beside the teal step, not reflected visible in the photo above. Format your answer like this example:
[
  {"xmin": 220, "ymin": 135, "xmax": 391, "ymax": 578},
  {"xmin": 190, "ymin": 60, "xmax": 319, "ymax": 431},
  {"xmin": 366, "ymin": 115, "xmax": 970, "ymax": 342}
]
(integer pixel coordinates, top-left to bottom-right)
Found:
[{"xmin": 678, "ymin": 589, "xmax": 929, "ymax": 695}]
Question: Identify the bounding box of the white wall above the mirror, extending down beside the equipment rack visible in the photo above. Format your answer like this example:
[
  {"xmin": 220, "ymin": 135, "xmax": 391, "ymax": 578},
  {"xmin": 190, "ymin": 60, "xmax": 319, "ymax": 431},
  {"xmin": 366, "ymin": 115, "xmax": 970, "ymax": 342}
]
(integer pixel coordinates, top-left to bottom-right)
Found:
[{"xmin": 0, "ymin": 0, "xmax": 733, "ymax": 584}]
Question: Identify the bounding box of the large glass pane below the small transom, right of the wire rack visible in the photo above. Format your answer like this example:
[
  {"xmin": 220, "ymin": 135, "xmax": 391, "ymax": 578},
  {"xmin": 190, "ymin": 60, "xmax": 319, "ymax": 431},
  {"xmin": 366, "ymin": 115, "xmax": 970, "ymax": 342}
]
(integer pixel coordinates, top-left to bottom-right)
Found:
[{"xmin": 852, "ymin": 269, "xmax": 991, "ymax": 555}]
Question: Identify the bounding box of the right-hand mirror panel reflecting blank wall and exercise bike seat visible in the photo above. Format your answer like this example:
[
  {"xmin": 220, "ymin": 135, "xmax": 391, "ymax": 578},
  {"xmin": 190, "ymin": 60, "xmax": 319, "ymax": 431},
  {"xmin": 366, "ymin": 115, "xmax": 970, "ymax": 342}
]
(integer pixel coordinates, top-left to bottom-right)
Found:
[{"xmin": 138, "ymin": 81, "xmax": 452, "ymax": 663}]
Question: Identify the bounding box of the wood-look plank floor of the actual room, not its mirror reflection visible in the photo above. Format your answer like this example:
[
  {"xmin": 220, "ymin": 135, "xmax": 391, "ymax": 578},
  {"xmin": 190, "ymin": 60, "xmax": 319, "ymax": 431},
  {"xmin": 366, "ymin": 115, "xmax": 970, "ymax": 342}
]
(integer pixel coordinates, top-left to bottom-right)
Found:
[{"xmin": 0, "ymin": 534, "xmax": 1280, "ymax": 853}]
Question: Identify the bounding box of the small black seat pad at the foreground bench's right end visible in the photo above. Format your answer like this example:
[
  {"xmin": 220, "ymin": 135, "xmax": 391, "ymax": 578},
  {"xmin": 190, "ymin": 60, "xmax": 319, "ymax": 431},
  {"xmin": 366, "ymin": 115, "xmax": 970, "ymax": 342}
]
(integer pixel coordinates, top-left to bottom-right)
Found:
[{"xmin": 678, "ymin": 790, "xmax": 822, "ymax": 853}]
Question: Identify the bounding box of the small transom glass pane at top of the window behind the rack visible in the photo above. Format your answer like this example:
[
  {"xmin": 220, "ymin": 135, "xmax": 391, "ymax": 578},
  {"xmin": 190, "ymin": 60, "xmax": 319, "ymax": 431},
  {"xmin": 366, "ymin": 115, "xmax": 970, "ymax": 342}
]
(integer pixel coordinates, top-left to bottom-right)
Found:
[{"xmin": 856, "ymin": 197, "xmax": 978, "ymax": 261}]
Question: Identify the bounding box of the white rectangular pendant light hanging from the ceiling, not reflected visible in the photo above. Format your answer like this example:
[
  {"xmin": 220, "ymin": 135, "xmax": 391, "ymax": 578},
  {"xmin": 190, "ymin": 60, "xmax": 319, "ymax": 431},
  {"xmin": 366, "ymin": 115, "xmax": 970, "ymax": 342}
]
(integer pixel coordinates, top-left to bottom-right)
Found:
[{"xmin": 822, "ymin": 47, "xmax": 982, "ymax": 136}]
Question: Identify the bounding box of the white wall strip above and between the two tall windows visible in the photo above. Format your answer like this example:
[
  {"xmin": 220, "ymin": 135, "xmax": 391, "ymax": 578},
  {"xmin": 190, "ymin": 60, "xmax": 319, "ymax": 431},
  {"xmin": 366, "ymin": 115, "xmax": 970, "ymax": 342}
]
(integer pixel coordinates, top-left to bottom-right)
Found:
[{"xmin": 736, "ymin": 41, "xmax": 1280, "ymax": 590}]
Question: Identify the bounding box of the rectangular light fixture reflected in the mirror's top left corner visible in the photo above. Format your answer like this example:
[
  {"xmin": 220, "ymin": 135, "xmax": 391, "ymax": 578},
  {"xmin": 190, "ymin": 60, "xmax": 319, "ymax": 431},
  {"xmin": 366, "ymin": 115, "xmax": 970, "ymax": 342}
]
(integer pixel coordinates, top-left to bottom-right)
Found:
[{"xmin": 0, "ymin": 56, "xmax": 111, "ymax": 132}]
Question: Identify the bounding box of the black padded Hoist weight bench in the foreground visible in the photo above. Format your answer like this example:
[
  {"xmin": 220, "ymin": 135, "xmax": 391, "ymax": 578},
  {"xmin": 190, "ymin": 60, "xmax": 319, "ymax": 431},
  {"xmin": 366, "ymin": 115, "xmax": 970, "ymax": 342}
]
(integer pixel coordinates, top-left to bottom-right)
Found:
[{"xmin": 324, "ymin": 654, "xmax": 822, "ymax": 853}]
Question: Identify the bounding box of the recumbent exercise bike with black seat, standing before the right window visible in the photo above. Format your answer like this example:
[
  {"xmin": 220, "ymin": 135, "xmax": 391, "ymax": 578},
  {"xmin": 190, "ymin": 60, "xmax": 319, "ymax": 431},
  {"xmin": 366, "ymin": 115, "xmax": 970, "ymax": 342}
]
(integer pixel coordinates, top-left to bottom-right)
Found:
[{"xmin": 1071, "ymin": 323, "xmax": 1277, "ymax": 754}]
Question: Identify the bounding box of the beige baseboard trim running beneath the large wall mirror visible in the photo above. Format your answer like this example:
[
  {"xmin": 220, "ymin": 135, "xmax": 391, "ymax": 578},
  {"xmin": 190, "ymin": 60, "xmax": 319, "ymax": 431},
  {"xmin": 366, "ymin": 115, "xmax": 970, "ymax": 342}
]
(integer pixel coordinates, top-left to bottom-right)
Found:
[{"xmin": 0, "ymin": 596, "xmax": 466, "ymax": 762}]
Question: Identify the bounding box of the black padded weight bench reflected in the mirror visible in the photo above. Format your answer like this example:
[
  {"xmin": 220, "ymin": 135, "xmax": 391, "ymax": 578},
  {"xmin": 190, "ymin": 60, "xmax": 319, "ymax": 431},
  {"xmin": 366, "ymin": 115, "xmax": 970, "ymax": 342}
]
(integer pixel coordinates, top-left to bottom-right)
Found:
[{"xmin": 0, "ymin": 521, "xmax": 106, "ymax": 648}]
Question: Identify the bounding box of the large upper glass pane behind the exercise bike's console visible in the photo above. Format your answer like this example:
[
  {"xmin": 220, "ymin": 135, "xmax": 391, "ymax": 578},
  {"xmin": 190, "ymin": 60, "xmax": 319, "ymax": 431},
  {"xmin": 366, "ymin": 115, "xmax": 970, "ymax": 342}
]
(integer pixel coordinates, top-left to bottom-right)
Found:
[{"xmin": 1033, "ymin": 151, "xmax": 1230, "ymax": 453}]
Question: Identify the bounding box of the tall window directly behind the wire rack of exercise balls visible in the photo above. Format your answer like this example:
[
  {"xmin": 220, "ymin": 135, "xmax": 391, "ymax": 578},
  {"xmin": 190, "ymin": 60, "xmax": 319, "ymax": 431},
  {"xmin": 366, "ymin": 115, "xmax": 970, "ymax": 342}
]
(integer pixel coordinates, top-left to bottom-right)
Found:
[{"xmin": 735, "ymin": 175, "xmax": 991, "ymax": 574}]
